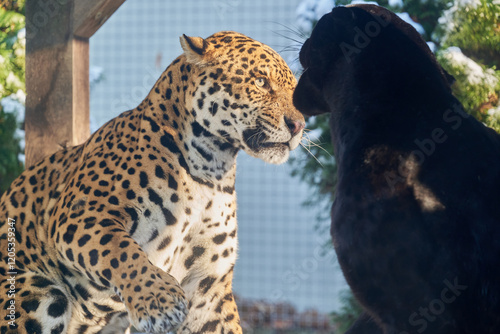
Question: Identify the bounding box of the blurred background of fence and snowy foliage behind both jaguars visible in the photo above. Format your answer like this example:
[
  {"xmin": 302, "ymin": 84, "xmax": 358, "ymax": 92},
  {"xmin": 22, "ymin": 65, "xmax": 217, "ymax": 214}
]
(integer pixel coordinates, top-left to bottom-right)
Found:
[{"xmin": 0, "ymin": 0, "xmax": 500, "ymax": 333}]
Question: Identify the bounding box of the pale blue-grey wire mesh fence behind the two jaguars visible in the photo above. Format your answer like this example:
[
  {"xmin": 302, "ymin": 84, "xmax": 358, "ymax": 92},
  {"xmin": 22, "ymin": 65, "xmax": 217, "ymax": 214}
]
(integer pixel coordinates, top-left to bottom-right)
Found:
[{"xmin": 90, "ymin": 0, "xmax": 346, "ymax": 333}]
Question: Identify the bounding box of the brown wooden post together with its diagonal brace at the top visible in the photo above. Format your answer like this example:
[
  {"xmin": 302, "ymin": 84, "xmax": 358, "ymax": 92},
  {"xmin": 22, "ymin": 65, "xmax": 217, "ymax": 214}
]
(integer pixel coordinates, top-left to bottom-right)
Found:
[{"xmin": 25, "ymin": 0, "xmax": 125, "ymax": 167}]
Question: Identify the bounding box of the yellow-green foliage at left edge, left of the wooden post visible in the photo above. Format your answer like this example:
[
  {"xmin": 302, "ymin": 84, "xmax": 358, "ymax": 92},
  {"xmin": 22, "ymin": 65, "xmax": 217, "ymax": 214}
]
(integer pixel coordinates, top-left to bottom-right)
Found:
[{"xmin": 0, "ymin": 1, "xmax": 26, "ymax": 193}]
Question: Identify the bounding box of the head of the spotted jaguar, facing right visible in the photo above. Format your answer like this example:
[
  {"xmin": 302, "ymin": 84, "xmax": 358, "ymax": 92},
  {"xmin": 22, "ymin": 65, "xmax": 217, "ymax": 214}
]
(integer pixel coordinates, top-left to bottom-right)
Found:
[{"xmin": 181, "ymin": 32, "xmax": 305, "ymax": 164}]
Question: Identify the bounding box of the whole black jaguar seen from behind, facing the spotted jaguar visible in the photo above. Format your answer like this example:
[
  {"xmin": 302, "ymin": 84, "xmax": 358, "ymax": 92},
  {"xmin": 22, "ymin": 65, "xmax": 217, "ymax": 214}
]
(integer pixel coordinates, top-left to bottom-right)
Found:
[{"xmin": 294, "ymin": 5, "xmax": 500, "ymax": 334}]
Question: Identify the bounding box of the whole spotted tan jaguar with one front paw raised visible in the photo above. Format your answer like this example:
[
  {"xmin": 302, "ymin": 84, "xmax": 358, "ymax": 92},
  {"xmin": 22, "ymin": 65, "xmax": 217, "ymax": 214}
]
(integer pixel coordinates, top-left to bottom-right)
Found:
[{"xmin": 0, "ymin": 32, "xmax": 304, "ymax": 334}]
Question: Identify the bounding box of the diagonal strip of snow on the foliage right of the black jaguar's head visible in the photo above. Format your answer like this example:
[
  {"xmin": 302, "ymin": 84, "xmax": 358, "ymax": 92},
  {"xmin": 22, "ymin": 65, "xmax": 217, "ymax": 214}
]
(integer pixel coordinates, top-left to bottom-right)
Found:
[{"xmin": 443, "ymin": 46, "xmax": 498, "ymax": 87}]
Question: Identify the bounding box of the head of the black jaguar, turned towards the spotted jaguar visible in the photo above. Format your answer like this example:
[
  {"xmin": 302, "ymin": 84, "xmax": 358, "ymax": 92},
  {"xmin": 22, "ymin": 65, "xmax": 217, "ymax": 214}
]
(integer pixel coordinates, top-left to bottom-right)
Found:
[{"xmin": 294, "ymin": 4, "xmax": 450, "ymax": 116}]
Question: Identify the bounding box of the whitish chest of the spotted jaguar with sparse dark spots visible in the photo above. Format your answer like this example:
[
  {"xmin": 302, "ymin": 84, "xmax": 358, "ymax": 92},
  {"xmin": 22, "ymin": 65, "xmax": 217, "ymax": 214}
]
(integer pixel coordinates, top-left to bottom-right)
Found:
[{"xmin": 131, "ymin": 177, "xmax": 237, "ymax": 281}]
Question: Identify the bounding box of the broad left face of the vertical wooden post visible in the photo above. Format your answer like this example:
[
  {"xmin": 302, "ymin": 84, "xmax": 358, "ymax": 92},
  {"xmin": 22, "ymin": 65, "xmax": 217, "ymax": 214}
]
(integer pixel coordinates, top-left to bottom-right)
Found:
[{"xmin": 25, "ymin": 0, "xmax": 77, "ymax": 167}]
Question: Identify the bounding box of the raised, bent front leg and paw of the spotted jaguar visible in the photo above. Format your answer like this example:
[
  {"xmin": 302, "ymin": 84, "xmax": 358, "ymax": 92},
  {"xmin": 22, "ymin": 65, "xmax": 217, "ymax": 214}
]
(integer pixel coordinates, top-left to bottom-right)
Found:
[{"xmin": 53, "ymin": 211, "xmax": 188, "ymax": 333}]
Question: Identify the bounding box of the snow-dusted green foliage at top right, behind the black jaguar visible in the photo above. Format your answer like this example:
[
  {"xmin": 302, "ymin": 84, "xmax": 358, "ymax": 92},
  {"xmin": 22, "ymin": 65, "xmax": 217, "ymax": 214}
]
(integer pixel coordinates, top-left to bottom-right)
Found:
[{"xmin": 435, "ymin": 0, "xmax": 500, "ymax": 132}]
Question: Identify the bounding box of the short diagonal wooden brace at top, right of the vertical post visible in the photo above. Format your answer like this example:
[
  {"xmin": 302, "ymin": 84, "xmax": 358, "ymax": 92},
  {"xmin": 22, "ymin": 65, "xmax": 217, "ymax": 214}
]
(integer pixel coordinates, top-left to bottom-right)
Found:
[{"xmin": 73, "ymin": 0, "xmax": 125, "ymax": 38}]
